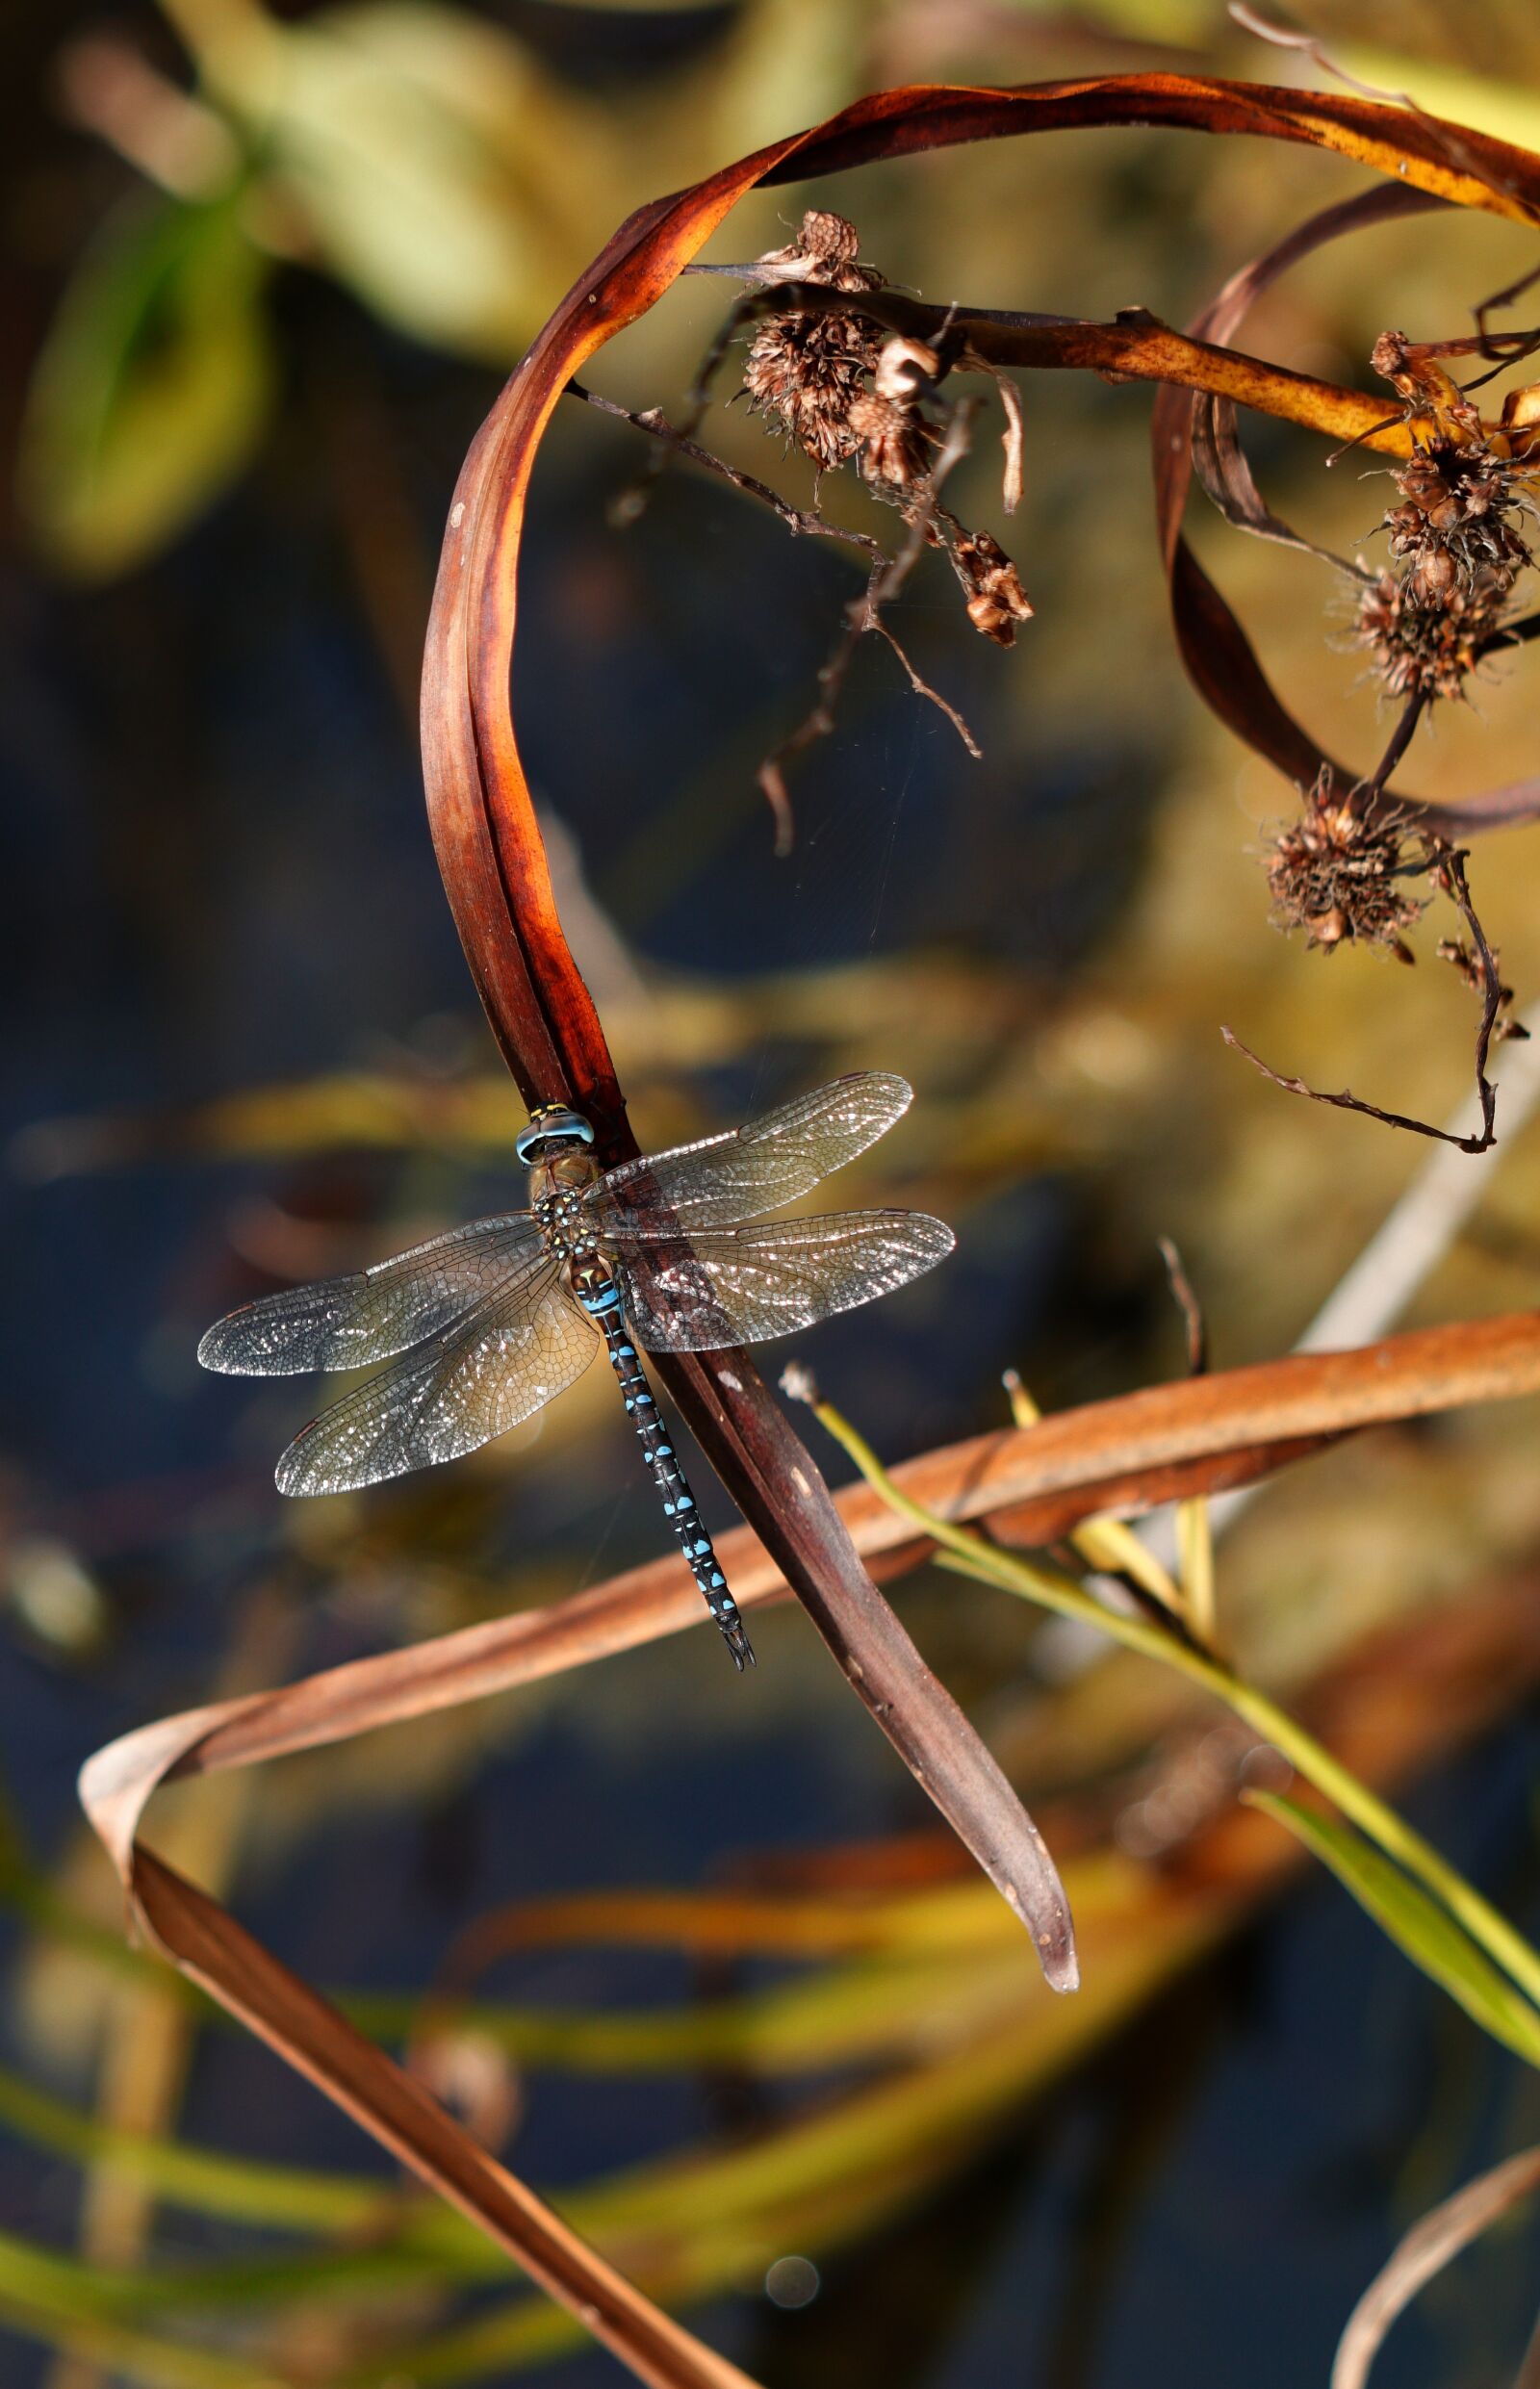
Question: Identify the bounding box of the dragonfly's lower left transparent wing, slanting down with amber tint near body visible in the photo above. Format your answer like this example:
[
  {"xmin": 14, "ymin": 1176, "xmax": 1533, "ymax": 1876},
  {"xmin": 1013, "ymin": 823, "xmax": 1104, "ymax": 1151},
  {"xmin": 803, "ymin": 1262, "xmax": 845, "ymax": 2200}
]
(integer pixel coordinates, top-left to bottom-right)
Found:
[{"xmin": 277, "ymin": 1254, "xmax": 600, "ymax": 1493}]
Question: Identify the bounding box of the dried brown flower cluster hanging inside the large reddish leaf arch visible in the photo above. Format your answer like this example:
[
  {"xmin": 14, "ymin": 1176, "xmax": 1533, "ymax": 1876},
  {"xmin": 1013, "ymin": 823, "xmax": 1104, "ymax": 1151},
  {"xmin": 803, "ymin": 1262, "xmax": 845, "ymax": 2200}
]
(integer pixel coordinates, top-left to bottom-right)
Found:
[{"xmin": 742, "ymin": 208, "xmax": 1032, "ymax": 648}]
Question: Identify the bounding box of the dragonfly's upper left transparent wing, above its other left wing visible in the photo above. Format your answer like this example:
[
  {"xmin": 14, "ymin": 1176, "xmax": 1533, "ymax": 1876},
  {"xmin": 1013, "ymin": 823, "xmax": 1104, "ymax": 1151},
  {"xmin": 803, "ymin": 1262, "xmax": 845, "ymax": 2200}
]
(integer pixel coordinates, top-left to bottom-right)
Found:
[{"xmin": 198, "ymin": 1211, "xmax": 540, "ymax": 1376}]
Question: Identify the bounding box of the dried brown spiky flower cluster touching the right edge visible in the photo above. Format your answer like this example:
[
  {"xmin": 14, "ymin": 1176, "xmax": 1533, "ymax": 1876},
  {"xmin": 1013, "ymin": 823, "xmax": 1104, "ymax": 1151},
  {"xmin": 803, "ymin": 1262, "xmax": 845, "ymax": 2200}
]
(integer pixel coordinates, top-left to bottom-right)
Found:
[{"xmin": 1354, "ymin": 332, "xmax": 1533, "ymax": 698}]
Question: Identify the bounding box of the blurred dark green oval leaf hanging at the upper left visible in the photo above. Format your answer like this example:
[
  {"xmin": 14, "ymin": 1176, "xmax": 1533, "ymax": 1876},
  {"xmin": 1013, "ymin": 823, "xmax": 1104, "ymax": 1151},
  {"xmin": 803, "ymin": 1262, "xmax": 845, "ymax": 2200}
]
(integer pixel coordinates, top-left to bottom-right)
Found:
[{"xmin": 19, "ymin": 193, "xmax": 274, "ymax": 580}]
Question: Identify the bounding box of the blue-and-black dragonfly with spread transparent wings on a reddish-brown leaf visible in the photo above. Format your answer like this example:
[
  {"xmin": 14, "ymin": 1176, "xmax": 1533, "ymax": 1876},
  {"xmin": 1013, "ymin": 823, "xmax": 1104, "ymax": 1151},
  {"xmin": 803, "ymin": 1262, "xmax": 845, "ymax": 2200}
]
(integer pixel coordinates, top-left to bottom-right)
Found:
[{"xmin": 198, "ymin": 1070, "xmax": 958, "ymax": 1670}]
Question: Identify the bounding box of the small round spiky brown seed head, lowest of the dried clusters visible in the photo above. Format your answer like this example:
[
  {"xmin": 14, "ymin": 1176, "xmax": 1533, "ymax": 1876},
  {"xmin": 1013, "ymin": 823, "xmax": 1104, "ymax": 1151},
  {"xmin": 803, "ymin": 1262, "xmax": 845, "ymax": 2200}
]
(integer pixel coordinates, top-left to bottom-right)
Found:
[{"xmin": 1268, "ymin": 772, "xmax": 1427, "ymax": 963}]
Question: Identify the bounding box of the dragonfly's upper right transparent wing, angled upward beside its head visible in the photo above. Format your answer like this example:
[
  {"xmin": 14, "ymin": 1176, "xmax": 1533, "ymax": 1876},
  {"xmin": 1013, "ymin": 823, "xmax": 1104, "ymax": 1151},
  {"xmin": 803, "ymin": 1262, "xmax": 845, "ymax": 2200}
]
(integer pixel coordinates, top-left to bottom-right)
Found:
[{"xmin": 587, "ymin": 1070, "xmax": 914, "ymax": 1242}]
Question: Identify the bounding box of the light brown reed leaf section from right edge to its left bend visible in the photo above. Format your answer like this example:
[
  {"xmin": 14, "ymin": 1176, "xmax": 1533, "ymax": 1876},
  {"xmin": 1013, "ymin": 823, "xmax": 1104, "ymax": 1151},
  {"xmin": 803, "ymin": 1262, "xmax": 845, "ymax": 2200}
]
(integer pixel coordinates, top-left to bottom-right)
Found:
[{"xmin": 81, "ymin": 1312, "xmax": 1540, "ymax": 1844}]
